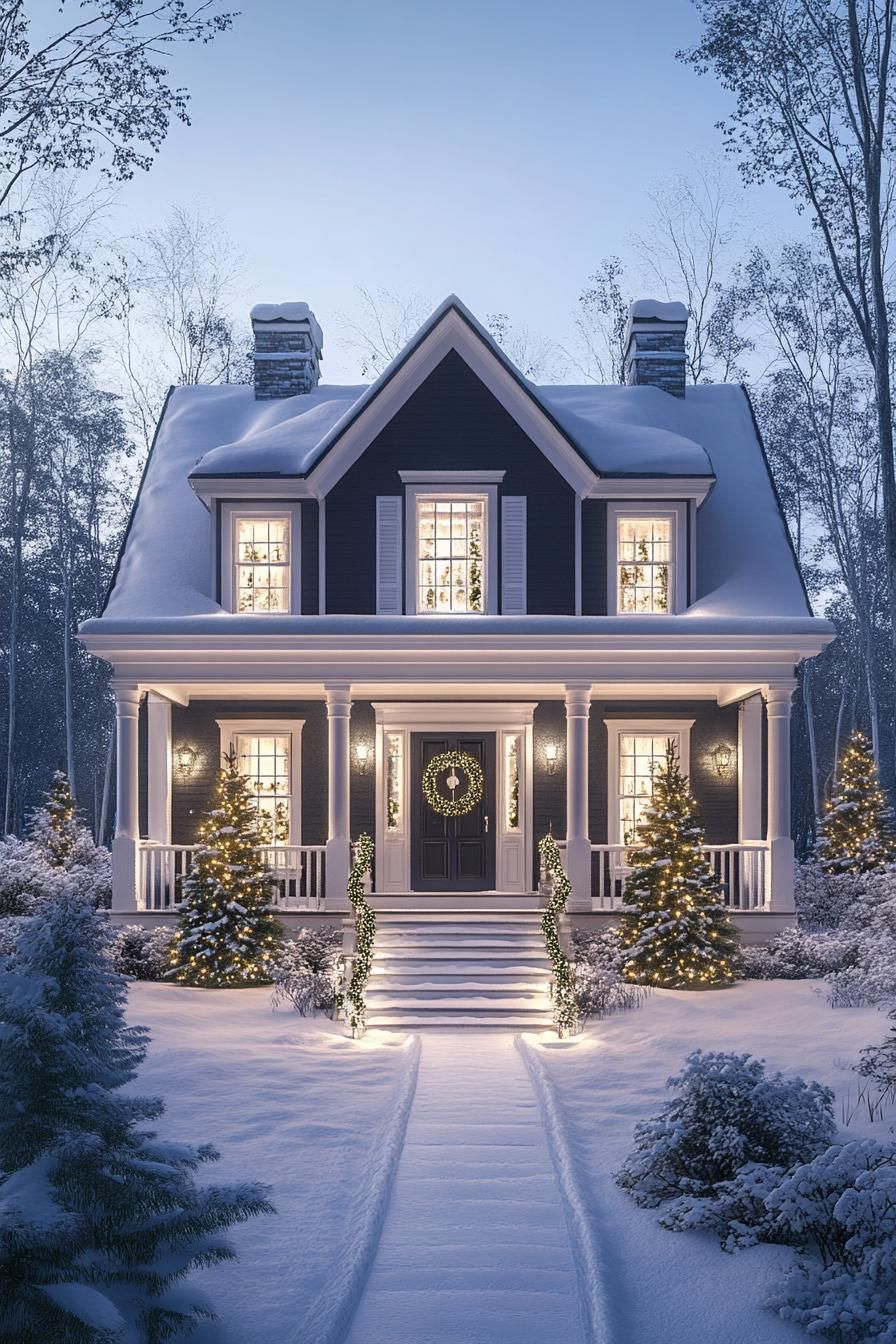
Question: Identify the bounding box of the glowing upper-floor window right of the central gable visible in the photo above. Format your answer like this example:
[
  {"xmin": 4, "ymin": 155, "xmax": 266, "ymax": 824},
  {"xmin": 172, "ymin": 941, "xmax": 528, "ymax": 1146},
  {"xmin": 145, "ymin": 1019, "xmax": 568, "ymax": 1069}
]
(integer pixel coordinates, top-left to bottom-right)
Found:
[{"xmin": 607, "ymin": 503, "xmax": 688, "ymax": 616}]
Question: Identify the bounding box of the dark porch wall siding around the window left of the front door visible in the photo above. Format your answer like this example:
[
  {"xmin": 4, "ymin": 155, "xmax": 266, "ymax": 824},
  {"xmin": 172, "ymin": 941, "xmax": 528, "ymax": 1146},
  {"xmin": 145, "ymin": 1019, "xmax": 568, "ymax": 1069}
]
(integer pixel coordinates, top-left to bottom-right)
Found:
[{"xmin": 171, "ymin": 700, "xmax": 326, "ymax": 844}]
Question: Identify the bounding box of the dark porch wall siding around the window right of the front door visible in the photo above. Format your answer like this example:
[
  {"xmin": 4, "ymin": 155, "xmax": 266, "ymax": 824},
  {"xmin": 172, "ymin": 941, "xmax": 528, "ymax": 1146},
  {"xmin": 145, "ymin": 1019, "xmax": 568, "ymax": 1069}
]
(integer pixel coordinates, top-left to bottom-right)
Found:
[{"xmin": 588, "ymin": 700, "xmax": 737, "ymax": 844}]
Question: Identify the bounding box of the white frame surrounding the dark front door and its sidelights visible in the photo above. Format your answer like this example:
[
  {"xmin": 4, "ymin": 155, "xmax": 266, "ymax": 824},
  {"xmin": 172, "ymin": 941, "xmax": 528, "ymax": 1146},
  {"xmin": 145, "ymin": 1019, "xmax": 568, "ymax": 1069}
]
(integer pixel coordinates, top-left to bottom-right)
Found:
[{"xmin": 373, "ymin": 700, "xmax": 535, "ymax": 895}]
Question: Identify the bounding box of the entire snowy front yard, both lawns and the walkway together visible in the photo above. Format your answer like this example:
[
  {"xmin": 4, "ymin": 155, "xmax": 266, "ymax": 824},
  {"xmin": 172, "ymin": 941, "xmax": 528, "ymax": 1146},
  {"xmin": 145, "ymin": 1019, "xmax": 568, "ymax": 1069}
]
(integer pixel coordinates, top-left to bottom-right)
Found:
[{"xmin": 130, "ymin": 981, "xmax": 895, "ymax": 1344}]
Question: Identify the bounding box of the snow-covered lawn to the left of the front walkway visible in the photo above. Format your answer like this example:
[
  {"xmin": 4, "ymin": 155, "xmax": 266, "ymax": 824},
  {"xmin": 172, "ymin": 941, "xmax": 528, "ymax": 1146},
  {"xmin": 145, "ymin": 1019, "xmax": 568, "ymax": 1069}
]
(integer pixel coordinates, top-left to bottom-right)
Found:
[{"xmin": 128, "ymin": 984, "xmax": 418, "ymax": 1344}]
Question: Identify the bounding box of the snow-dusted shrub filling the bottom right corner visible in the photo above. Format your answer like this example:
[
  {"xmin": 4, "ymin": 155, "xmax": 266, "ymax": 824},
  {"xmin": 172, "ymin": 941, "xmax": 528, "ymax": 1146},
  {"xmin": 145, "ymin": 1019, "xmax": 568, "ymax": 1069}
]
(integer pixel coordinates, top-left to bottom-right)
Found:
[{"xmin": 766, "ymin": 1138, "xmax": 896, "ymax": 1344}]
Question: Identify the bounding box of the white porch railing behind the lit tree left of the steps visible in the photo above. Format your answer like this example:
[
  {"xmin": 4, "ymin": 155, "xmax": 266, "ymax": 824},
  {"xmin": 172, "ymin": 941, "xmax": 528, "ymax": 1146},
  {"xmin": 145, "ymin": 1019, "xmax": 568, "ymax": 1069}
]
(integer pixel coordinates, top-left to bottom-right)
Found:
[{"xmin": 137, "ymin": 840, "xmax": 326, "ymax": 910}]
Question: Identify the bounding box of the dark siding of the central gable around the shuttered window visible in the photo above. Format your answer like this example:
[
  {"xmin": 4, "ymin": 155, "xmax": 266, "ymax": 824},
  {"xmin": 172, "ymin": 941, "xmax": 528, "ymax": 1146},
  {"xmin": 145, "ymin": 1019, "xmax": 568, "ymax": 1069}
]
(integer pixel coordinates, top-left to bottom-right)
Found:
[{"xmin": 326, "ymin": 352, "xmax": 575, "ymax": 616}]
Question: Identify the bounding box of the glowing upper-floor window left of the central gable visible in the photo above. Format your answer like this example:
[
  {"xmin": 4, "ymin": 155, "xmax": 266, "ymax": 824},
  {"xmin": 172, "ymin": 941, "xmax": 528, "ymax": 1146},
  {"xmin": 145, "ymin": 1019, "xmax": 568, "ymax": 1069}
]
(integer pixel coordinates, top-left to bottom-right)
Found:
[{"xmin": 220, "ymin": 504, "xmax": 301, "ymax": 616}]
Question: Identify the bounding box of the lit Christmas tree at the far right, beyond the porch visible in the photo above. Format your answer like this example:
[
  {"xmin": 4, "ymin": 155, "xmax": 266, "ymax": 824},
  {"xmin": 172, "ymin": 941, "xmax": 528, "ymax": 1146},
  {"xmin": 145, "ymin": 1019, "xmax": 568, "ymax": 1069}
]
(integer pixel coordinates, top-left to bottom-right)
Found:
[{"xmin": 815, "ymin": 728, "xmax": 896, "ymax": 872}]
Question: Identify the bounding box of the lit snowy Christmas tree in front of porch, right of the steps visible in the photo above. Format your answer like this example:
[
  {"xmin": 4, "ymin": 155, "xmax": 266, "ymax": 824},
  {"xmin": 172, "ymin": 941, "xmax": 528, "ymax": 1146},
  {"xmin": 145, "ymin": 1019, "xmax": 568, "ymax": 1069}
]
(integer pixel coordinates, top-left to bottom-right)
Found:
[{"xmin": 619, "ymin": 742, "xmax": 737, "ymax": 989}]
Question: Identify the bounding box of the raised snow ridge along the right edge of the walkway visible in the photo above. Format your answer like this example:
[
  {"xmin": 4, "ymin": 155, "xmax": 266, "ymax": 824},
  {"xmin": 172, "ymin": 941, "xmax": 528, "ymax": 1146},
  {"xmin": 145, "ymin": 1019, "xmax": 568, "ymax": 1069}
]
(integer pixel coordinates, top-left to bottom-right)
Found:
[{"xmin": 514, "ymin": 1036, "xmax": 621, "ymax": 1344}]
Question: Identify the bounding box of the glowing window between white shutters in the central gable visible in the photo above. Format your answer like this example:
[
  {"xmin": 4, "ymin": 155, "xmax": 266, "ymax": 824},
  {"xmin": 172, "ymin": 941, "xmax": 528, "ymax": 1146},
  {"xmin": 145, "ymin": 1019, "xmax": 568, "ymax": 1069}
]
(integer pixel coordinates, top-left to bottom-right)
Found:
[{"xmin": 416, "ymin": 497, "xmax": 486, "ymax": 614}]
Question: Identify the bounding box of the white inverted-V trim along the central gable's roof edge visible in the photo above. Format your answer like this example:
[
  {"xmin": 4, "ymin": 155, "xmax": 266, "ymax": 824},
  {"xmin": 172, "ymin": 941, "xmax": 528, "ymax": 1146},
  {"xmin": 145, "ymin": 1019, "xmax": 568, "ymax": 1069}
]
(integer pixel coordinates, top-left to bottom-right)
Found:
[{"xmin": 308, "ymin": 308, "xmax": 598, "ymax": 496}]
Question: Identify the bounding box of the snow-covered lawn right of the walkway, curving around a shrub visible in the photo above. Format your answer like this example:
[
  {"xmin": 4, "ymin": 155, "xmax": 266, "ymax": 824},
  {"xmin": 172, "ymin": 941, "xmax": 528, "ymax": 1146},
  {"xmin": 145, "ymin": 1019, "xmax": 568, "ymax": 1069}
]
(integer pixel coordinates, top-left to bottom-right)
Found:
[{"xmin": 521, "ymin": 980, "xmax": 896, "ymax": 1344}]
